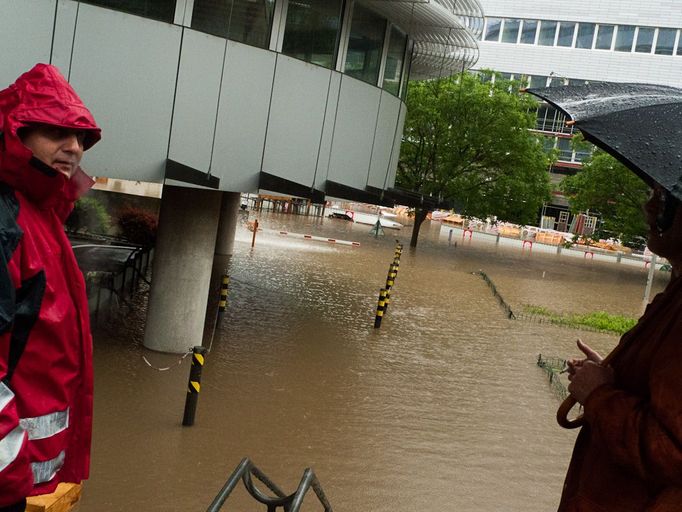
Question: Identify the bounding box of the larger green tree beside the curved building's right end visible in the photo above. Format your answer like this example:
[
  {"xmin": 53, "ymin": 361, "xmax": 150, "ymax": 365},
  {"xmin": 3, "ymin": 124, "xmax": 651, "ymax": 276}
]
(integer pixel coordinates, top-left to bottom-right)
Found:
[{"xmin": 396, "ymin": 72, "xmax": 550, "ymax": 247}]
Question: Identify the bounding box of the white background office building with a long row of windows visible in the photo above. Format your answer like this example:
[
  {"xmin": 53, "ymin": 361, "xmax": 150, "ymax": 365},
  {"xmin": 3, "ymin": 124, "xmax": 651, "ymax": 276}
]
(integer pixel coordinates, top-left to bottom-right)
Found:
[{"xmin": 476, "ymin": 0, "xmax": 682, "ymax": 227}]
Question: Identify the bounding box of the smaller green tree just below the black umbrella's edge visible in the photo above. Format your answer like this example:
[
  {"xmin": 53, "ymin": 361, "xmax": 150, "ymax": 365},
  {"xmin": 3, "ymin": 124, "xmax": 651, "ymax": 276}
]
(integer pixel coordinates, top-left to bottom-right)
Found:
[{"xmin": 561, "ymin": 139, "xmax": 649, "ymax": 245}]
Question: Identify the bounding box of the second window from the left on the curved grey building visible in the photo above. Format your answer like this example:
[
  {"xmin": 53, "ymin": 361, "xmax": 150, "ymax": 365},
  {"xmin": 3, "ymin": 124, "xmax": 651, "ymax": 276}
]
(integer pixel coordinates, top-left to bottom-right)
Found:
[{"xmin": 192, "ymin": 0, "xmax": 275, "ymax": 48}]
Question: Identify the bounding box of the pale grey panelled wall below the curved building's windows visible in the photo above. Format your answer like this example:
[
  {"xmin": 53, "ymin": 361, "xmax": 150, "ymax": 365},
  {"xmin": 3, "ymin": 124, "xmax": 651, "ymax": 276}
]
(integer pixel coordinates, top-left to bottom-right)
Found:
[{"xmin": 0, "ymin": 0, "xmax": 404, "ymax": 196}]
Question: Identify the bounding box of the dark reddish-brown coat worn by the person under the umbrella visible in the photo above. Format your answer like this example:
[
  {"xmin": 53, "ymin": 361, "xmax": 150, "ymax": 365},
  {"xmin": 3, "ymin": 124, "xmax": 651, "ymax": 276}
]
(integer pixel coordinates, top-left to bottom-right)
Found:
[{"xmin": 559, "ymin": 277, "xmax": 682, "ymax": 512}]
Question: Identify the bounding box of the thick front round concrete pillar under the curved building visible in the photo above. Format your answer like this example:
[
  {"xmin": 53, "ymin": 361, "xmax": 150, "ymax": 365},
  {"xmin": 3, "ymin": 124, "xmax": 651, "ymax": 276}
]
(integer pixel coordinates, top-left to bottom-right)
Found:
[{"xmin": 144, "ymin": 186, "xmax": 221, "ymax": 353}]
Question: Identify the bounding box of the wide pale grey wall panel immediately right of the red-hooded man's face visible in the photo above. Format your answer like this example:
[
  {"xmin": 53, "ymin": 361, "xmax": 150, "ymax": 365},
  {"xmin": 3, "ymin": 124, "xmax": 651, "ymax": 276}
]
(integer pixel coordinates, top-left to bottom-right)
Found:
[{"xmin": 71, "ymin": 4, "xmax": 181, "ymax": 182}]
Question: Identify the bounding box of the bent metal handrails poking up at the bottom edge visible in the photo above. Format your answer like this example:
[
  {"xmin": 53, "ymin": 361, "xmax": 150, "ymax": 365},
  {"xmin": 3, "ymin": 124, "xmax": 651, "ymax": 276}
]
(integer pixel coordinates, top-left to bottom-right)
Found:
[{"xmin": 206, "ymin": 458, "xmax": 332, "ymax": 512}]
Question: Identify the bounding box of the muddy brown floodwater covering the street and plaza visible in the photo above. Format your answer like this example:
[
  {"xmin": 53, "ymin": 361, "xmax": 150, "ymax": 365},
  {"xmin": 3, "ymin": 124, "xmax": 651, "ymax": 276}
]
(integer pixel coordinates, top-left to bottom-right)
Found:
[{"xmin": 78, "ymin": 214, "xmax": 669, "ymax": 512}]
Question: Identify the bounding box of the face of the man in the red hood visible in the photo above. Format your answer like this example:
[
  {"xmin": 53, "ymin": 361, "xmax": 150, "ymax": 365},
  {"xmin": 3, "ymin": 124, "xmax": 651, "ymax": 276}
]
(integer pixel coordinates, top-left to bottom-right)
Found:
[{"xmin": 21, "ymin": 125, "xmax": 85, "ymax": 178}]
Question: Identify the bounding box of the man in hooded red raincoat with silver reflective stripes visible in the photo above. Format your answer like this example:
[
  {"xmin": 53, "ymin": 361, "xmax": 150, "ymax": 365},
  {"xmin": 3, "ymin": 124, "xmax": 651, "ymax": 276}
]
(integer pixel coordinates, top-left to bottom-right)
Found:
[{"xmin": 0, "ymin": 64, "xmax": 100, "ymax": 511}]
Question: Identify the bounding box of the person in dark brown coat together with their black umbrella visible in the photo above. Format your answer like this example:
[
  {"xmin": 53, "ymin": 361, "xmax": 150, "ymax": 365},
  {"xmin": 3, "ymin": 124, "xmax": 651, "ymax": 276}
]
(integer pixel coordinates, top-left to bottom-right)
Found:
[{"xmin": 527, "ymin": 84, "xmax": 682, "ymax": 512}]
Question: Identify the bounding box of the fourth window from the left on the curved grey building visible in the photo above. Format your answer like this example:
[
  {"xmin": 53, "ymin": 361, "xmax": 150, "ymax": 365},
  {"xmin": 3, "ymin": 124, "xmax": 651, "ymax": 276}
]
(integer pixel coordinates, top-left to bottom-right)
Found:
[{"xmin": 344, "ymin": 3, "xmax": 386, "ymax": 85}]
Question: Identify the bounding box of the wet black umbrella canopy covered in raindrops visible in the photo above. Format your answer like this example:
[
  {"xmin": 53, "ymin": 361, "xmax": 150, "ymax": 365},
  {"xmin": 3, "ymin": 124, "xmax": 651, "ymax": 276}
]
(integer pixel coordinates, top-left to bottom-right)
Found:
[{"xmin": 526, "ymin": 83, "xmax": 682, "ymax": 200}]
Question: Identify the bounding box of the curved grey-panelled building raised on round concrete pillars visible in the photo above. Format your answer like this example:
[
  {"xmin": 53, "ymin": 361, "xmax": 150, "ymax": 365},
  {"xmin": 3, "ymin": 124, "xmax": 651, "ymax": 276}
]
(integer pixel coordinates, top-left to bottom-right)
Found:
[{"xmin": 0, "ymin": 0, "xmax": 482, "ymax": 352}]
